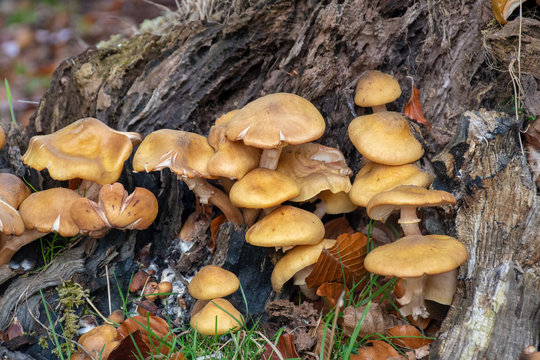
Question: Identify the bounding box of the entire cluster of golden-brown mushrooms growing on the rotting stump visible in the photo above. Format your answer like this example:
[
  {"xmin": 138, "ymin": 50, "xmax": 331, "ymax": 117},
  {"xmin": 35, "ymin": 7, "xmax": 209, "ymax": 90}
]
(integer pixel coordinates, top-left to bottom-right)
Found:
[{"xmin": 0, "ymin": 71, "xmax": 466, "ymax": 344}]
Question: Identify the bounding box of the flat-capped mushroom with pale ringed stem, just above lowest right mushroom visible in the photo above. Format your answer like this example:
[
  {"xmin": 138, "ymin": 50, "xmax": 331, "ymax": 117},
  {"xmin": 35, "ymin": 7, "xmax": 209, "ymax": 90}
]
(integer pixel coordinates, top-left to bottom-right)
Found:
[{"xmin": 367, "ymin": 185, "xmax": 456, "ymax": 235}]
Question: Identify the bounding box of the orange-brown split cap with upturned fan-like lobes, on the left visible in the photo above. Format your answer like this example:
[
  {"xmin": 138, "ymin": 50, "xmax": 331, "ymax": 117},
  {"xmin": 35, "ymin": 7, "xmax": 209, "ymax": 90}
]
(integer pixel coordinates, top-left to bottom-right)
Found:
[{"xmin": 70, "ymin": 183, "xmax": 158, "ymax": 232}]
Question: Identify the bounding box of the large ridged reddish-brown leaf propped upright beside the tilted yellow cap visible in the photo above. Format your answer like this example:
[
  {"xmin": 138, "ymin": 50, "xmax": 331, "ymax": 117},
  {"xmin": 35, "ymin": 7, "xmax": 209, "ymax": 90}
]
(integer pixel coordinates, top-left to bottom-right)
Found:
[{"xmin": 306, "ymin": 232, "xmax": 368, "ymax": 291}]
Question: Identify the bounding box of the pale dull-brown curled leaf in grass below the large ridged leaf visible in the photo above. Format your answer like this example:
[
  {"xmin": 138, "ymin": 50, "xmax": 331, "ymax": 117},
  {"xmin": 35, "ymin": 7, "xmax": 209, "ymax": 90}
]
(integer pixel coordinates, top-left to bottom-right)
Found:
[{"xmin": 341, "ymin": 303, "xmax": 394, "ymax": 337}]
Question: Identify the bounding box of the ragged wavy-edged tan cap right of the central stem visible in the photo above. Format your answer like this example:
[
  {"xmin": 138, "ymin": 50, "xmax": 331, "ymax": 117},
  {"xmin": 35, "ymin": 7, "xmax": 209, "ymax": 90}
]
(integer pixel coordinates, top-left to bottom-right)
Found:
[{"xmin": 276, "ymin": 143, "xmax": 352, "ymax": 202}]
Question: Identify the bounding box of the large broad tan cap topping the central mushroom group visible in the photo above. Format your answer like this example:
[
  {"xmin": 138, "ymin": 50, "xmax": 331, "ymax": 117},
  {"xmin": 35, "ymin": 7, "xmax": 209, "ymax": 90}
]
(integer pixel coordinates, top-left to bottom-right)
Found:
[{"xmin": 227, "ymin": 93, "xmax": 326, "ymax": 149}]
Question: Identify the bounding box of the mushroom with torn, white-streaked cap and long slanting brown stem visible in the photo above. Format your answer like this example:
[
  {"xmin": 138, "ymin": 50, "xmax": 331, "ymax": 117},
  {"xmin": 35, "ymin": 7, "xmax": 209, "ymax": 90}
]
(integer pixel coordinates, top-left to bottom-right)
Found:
[{"xmin": 133, "ymin": 129, "xmax": 244, "ymax": 224}]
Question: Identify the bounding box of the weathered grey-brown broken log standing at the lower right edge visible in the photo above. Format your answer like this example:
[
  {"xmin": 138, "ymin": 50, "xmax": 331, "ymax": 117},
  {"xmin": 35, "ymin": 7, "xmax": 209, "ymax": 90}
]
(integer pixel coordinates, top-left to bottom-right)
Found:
[{"xmin": 430, "ymin": 111, "xmax": 540, "ymax": 359}]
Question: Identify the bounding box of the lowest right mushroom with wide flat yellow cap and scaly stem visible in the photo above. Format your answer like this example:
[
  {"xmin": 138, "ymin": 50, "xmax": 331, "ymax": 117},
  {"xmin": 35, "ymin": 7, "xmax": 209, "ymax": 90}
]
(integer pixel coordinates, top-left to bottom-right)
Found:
[{"xmin": 364, "ymin": 235, "xmax": 467, "ymax": 320}]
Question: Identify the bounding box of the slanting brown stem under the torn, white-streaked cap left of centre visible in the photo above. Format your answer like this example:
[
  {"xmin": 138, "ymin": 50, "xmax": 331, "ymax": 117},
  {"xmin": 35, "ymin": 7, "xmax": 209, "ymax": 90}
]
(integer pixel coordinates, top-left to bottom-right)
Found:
[{"xmin": 184, "ymin": 176, "xmax": 244, "ymax": 224}]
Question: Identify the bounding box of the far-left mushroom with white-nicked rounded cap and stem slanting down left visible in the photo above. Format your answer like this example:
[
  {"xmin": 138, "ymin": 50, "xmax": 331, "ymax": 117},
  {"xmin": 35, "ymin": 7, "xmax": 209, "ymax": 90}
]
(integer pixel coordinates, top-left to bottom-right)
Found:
[{"xmin": 0, "ymin": 188, "xmax": 80, "ymax": 265}]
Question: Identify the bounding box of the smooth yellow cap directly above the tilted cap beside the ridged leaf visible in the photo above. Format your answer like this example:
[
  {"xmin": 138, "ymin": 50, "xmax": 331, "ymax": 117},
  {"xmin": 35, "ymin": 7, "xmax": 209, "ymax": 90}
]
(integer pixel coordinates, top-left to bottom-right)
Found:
[{"xmin": 246, "ymin": 205, "xmax": 324, "ymax": 247}]
